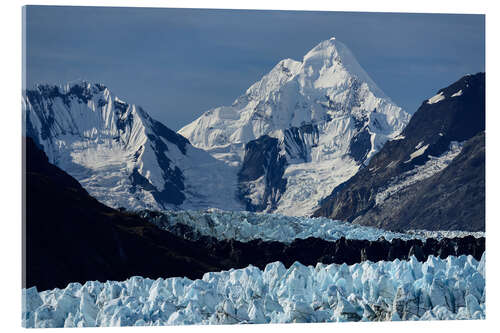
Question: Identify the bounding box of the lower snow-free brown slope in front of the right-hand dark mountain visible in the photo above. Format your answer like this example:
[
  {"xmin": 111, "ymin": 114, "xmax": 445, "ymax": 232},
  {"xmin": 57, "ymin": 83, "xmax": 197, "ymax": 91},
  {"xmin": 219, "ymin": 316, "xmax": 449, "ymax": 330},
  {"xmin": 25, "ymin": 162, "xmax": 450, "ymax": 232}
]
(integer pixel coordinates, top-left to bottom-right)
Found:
[{"xmin": 348, "ymin": 132, "xmax": 485, "ymax": 231}]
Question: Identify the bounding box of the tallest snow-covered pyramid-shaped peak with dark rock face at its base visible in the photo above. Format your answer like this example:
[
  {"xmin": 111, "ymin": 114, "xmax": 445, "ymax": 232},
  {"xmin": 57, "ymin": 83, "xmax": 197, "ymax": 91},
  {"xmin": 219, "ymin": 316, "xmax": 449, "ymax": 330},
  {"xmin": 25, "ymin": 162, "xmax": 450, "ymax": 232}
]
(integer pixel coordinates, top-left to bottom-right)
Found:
[{"xmin": 178, "ymin": 38, "xmax": 410, "ymax": 215}]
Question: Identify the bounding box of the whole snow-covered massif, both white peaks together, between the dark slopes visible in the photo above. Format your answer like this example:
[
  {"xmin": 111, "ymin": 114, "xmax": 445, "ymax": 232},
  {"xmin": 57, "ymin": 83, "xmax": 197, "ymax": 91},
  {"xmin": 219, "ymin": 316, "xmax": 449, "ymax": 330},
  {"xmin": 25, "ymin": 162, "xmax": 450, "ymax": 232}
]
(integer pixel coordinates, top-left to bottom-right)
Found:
[{"xmin": 23, "ymin": 39, "xmax": 409, "ymax": 215}]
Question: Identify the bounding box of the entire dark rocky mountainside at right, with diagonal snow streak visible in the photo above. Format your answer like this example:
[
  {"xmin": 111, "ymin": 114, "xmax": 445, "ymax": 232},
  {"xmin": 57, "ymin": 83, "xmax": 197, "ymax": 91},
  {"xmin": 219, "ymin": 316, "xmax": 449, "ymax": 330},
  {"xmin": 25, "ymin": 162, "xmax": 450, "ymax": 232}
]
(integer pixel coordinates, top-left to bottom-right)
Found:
[{"xmin": 314, "ymin": 73, "xmax": 485, "ymax": 231}]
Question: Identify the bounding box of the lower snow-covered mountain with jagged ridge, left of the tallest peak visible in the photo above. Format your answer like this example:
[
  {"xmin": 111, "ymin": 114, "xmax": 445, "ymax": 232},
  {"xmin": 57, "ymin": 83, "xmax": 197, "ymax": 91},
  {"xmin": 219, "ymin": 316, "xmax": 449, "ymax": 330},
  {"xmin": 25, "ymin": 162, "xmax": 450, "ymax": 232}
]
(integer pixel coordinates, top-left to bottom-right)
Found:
[{"xmin": 23, "ymin": 81, "xmax": 241, "ymax": 210}]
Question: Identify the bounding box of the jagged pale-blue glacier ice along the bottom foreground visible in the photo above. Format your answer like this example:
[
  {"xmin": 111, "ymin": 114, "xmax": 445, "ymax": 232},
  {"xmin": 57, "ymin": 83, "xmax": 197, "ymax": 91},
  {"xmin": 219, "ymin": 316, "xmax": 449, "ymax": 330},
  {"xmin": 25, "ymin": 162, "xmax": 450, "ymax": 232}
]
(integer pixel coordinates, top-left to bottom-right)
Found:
[{"xmin": 23, "ymin": 254, "xmax": 485, "ymax": 327}]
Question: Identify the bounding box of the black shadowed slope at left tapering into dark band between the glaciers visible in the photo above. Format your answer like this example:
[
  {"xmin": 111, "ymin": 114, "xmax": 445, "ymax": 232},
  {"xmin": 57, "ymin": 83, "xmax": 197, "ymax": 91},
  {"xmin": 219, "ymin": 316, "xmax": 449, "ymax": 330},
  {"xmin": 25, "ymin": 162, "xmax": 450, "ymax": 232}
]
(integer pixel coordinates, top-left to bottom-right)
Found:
[{"xmin": 23, "ymin": 138, "xmax": 484, "ymax": 290}]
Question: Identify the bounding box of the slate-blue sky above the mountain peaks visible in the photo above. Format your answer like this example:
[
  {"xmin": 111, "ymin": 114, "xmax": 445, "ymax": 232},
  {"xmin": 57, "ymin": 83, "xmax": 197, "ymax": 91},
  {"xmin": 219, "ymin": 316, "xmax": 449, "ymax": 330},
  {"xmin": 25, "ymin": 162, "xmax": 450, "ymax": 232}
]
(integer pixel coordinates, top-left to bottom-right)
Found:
[{"xmin": 26, "ymin": 6, "xmax": 485, "ymax": 130}]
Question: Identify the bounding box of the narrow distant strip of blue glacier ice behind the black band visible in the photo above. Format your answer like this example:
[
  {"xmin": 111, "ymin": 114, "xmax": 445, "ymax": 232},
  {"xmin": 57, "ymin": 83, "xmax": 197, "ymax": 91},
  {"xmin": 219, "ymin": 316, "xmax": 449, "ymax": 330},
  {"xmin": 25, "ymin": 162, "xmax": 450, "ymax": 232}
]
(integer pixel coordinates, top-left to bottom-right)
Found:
[{"xmin": 141, "ymin": 209, "xmax": 484, "ymax": 243}]
